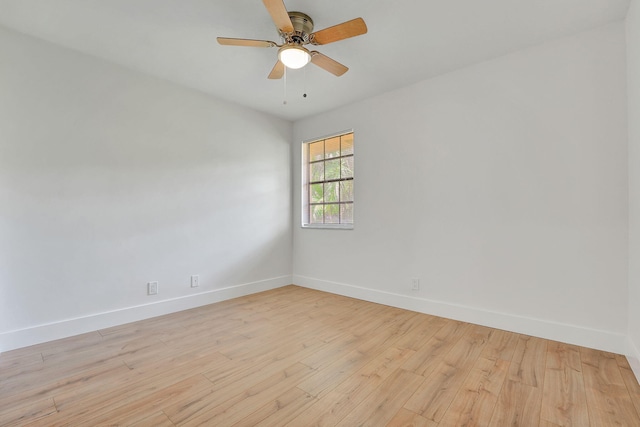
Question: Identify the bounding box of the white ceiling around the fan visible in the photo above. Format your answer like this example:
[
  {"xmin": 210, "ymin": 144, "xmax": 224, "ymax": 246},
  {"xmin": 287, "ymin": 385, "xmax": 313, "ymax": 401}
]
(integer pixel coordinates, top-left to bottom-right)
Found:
[{"xmin": 0, "ymin": 0, "xmax": 629, "ymax": 120}]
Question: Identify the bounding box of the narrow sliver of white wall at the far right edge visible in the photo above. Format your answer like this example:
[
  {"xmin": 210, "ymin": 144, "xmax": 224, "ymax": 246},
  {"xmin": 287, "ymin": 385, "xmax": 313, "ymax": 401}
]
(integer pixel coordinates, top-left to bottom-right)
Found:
[{"xmin": 626, "ymin": 0, "xmax": 640, "ymax": 379}]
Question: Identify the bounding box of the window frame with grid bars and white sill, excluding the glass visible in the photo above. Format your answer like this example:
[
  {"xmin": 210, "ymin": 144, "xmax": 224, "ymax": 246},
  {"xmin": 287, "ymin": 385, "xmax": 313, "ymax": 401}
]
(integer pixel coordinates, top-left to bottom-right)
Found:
[{"xmin": 300, "ymin": 129, "xmax": 355, "ymax": 230}]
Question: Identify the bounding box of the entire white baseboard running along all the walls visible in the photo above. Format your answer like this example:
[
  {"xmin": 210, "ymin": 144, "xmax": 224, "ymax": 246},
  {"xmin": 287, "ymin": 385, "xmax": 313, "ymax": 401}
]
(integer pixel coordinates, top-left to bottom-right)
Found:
[{"xmin": 0, "ymin": 275, "xmax": 640, "ymax": 368}]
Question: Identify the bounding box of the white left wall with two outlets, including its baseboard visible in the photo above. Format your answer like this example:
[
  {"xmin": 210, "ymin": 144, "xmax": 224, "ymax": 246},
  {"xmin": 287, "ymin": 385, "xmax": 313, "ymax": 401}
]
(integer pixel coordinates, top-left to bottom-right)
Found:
[{"xmin": 0, "ymin": 28, "xmax": 292, "ymax": 351}]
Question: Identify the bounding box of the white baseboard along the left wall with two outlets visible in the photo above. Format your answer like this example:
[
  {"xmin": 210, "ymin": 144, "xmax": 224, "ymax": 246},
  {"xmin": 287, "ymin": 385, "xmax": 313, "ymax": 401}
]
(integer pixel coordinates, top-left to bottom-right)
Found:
[{"xmin": 0, "ymin": 276, "xmax": 292, "ymax": 353}]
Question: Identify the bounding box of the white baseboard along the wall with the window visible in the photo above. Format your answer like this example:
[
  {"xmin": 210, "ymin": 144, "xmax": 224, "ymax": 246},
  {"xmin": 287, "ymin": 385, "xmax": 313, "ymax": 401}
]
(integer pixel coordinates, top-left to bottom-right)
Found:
[{"xmin": 293, "ymin": 274, "xmax": 638, "ymax": 356}]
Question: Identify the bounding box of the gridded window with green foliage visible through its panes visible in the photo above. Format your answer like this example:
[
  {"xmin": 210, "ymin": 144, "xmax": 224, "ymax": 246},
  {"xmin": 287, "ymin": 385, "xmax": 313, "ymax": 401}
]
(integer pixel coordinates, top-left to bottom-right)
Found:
[{"xmin": 302, "ymin": 132, "xmax": 353, "ymax": 228}]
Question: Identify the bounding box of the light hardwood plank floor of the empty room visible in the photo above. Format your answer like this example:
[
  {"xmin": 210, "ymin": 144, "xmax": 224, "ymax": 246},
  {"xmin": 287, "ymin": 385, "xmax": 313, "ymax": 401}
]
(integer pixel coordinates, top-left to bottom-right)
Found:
[{"xmin": 0, "ymin": 286, "xmax": 640, "ymax": 427}]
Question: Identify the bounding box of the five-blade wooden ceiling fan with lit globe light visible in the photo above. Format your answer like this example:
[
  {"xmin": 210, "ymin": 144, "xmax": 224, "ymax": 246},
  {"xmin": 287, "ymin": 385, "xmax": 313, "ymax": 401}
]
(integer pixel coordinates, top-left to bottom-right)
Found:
[{"xmin": 218, "ymin": 0, "xmax": 367, "ymax": 79}]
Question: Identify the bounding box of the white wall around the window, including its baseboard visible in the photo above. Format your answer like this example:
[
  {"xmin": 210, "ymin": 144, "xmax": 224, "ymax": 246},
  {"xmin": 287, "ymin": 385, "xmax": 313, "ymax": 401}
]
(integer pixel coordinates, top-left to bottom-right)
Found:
[{"xmin": 293, "ymin": 23, "xmax": 628, "ymax": 352}]
